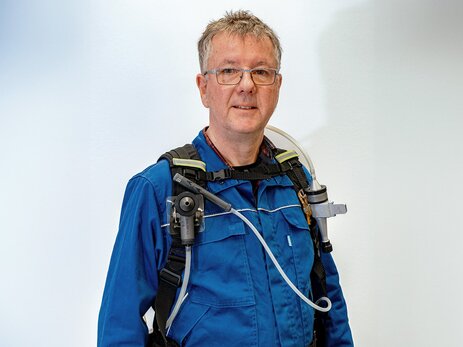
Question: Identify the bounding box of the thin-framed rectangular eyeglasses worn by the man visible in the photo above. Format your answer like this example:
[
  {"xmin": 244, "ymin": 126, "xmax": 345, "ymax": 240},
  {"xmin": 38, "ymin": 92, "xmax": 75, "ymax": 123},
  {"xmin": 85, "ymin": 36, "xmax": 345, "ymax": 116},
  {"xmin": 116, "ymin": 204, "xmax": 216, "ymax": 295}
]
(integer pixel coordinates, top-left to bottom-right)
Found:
[{"xmin": 203, "ymin": 67, "xmax": 278, "ymax": 86}]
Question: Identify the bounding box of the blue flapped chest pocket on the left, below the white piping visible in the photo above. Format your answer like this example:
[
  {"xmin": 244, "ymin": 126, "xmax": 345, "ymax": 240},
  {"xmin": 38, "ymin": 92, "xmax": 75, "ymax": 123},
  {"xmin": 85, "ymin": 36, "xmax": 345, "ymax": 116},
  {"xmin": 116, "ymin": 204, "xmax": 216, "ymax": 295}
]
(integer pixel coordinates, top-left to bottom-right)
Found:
[{"xmin": 189, "ymin": 214, "xmax": 255, "ymax": 307}]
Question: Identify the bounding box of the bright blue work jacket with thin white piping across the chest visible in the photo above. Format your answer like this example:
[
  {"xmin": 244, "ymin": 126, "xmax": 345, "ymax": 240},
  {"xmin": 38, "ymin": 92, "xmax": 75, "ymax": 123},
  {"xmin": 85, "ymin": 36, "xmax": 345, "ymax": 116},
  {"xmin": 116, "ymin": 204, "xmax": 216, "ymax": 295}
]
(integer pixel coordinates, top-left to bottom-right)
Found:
[{"xmin": 98, "ymin": 132, "xmax": 353, "ymax": 347}]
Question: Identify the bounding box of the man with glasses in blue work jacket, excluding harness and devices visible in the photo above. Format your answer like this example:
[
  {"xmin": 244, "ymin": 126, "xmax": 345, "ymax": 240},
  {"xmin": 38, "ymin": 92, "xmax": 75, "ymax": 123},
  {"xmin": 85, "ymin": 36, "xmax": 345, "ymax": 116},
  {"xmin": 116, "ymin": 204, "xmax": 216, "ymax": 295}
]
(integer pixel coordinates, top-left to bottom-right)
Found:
[{"xmin": 98, "ymin": 11, "xmax": 353, "ymax": 347}]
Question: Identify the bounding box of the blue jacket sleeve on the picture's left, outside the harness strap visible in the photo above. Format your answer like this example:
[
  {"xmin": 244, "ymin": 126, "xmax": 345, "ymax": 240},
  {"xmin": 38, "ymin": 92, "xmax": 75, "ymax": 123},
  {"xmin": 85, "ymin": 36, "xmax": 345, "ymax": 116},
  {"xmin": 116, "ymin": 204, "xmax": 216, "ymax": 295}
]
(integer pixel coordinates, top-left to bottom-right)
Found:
[{"xmin": 98, "ymin": 176, "xmax": 168, "ymax": 347}]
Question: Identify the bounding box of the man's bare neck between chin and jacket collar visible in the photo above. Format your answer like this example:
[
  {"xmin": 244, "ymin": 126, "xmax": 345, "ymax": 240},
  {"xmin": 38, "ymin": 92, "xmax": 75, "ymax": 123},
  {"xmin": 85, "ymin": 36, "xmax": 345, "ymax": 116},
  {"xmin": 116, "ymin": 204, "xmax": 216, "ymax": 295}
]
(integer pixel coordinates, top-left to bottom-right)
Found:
[{"xmin": 207, "ymin": 128, "xmax": 264, "ymax": 166}]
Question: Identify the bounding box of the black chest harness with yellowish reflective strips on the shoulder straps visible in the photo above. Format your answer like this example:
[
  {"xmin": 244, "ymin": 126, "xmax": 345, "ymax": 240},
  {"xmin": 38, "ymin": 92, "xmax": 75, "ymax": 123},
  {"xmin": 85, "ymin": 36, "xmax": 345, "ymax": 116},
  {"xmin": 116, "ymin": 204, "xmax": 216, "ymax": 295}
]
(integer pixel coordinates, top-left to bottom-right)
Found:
[{"xmin": 147, "ymin": 144, "xmax": 328, "ymax": 347}]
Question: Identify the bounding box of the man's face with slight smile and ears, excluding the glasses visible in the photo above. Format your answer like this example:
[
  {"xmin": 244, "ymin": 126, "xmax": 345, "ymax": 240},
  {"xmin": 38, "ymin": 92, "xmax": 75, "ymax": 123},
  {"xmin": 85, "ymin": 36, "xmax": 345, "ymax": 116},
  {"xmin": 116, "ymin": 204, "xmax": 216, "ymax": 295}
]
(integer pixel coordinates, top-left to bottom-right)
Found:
[{"xmin": 196, "ymin": 33, "xmax": 281, "ymax": 138}]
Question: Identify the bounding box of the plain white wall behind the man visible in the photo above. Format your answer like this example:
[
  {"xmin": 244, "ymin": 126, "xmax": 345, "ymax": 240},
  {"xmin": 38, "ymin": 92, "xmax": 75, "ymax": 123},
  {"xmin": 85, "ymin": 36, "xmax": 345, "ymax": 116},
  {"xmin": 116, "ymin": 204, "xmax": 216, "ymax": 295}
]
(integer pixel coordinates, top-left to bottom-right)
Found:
[{"xmin": 0, "ymin": 0, "xmax": 463, "ymax": 347}]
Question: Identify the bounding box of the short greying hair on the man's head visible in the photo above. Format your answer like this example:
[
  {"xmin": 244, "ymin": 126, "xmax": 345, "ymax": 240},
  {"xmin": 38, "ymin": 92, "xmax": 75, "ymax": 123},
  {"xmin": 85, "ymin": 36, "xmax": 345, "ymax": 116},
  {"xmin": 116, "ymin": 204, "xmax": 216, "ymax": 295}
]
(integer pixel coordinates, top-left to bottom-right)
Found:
[{"xmin": 198, "ymin": 10, "xmax": 282, "ymax": 72}]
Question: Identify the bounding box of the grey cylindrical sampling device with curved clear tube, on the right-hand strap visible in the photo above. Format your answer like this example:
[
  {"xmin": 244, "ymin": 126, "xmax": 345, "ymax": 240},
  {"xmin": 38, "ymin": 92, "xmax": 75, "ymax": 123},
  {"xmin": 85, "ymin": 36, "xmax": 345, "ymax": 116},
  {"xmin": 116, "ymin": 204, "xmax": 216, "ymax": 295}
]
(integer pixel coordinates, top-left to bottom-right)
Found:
[{"xmin": 266, "ymin": 125, "xmax": 347, "ymax": 253}]
